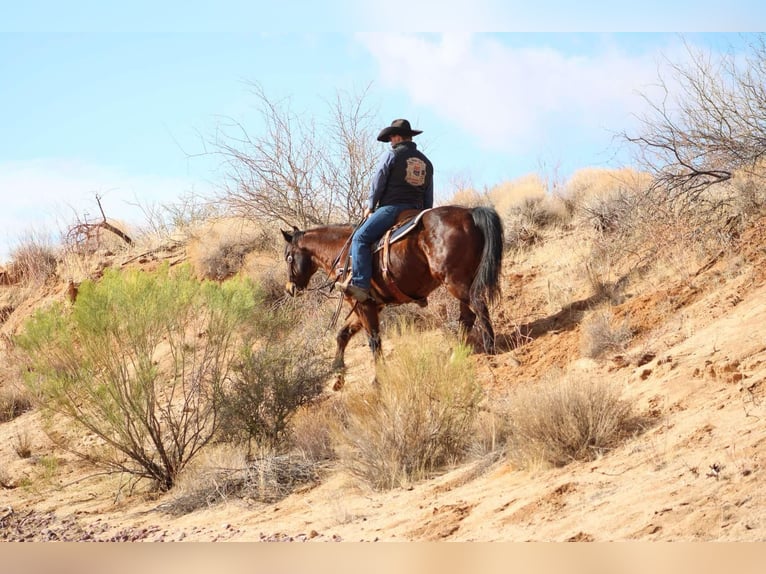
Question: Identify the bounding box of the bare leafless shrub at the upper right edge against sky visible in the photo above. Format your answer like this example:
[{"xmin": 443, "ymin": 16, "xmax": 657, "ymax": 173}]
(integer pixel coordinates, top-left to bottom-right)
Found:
[{"xmin": 623, "ymin": 34, "xmax": 766, "ymax": 208}]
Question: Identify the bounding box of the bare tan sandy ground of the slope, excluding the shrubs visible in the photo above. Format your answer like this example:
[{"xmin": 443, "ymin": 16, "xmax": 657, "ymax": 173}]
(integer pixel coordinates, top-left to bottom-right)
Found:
[{"xmin": 0, "ymin": 214, "xmax": 766, "ymax": 541}]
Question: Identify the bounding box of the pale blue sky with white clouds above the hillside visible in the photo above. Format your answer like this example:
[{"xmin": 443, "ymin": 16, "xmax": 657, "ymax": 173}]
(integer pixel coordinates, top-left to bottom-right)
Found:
[{"xmin": 0, "ymin": 0, "xmax": 766, "ymax": 263}]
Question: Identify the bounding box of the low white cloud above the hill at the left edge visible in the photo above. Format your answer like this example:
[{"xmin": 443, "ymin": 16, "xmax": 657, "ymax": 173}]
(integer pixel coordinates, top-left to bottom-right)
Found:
[{"xmin": 0, "ymin": 159, "xmax": 198, "ymax": 262}]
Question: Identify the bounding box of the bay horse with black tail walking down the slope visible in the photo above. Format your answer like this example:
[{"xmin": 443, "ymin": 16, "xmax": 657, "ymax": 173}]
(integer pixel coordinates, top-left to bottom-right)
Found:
[{"xmin": 281, "ymin": 206, "xmax": 503, "ymax": 370}]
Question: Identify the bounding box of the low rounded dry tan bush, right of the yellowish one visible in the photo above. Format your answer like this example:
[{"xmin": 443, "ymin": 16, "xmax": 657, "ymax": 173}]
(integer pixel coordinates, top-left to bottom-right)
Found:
[{"xmin": 508, "ymin": 378, "xmax": 637, "ymax": 468}]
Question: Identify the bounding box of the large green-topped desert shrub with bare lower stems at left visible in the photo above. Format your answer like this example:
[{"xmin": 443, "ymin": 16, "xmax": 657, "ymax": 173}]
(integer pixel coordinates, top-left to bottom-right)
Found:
[{"xmin": 18, "ymin": 266, "xmax": 256, "ymax": 490}]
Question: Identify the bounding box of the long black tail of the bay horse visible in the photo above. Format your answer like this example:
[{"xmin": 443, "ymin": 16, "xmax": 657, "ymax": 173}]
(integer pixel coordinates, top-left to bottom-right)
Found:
[{"xmin": 471, "ymin": 206, "xmax": 503, "ymax": 303}]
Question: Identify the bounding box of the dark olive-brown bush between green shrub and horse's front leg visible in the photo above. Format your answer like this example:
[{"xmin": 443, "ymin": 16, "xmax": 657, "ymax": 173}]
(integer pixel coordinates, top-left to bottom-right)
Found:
[{"xmin": 223, "ymin": 338, "xmax": 330, "ymax": 449}]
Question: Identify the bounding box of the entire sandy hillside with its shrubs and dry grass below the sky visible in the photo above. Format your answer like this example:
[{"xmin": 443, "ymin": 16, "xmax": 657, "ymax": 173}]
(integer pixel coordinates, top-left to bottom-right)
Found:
[{"xmin": 0, "ymin": 164, "xmax": 766, "ymax": 541}]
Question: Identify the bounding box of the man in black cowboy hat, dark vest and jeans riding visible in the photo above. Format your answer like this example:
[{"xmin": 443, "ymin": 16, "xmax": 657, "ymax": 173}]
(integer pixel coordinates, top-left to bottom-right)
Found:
[{"xmin": 340, "ymin": 119, "xmax": 434, "ymax": 303}]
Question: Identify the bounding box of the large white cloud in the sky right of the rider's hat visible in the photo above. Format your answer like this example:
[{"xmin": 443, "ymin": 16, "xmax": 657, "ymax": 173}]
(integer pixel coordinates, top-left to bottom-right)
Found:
[{"xmin": 360, "ymin": 34, "xmax": 657, "ymax": 153}]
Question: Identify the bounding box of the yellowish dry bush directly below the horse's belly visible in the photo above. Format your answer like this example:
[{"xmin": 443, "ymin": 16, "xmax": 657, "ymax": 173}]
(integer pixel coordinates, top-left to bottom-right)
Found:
[{"xmin": 335, "ymin": 332, "xmax": 482, "ymax": 489}]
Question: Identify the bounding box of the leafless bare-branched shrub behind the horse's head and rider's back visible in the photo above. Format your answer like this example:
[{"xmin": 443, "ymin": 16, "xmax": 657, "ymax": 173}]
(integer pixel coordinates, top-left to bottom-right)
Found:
[{"xmin": 211, "ymin": 84, "xmax": 379, "ymax": 229}]
